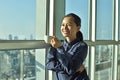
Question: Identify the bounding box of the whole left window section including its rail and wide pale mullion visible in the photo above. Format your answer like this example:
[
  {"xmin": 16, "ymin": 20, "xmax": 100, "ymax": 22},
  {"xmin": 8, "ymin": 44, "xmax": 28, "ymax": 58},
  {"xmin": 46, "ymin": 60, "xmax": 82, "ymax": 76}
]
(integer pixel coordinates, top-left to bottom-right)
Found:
[{"xmin": 0, "ymin": 0, "xmax": 48, "ymax": 80}]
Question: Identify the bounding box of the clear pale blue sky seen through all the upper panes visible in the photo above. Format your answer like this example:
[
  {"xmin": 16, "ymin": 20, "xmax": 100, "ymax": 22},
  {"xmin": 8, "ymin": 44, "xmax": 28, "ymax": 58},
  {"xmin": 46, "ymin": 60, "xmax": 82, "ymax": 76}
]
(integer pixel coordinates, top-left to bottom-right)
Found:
[{"xmin": 0, "ymin": 0, "xmax": 117, "ymax": 39}]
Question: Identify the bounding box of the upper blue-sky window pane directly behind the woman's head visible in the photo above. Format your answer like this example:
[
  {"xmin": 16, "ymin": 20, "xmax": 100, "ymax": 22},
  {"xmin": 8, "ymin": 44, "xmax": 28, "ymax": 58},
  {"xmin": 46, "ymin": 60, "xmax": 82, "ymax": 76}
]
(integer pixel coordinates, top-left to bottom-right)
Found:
[{"xmin": 65, "ymin": 0, "xmax": 89, "ymax": 40}]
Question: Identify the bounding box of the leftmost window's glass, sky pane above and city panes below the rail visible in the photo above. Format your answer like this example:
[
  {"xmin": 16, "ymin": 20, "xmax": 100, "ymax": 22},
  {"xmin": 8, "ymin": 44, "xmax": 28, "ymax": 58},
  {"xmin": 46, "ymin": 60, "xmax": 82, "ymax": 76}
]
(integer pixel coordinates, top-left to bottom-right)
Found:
[{"xmin": 0, "ymin": 0, "xmax": 36, "ymax": 80}]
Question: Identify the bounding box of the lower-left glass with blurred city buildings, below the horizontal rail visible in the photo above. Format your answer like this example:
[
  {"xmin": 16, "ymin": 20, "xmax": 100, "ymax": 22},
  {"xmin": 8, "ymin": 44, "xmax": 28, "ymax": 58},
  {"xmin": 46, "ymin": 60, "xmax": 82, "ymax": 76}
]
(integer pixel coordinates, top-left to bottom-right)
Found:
[{"xmin": 0, "ymin": 50, "xmax": 35, "ymax": 80}]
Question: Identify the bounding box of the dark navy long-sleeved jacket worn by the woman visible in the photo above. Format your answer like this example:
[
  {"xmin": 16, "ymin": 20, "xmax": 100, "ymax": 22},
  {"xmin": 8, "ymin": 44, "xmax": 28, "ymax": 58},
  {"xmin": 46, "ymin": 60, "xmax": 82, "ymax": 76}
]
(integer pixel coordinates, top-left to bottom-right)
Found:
[{"xmin": 46, "ymin": 39, "xmax": 88, "ymax": 80}]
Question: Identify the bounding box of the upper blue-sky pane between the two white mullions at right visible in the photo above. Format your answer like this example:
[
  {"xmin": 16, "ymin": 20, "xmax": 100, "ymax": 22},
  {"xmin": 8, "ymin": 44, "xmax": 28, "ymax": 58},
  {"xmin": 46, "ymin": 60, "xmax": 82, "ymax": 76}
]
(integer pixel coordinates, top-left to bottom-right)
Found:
[{"xmin": 96, "ymin": 0, "xmax": 113, "ymax": 40}]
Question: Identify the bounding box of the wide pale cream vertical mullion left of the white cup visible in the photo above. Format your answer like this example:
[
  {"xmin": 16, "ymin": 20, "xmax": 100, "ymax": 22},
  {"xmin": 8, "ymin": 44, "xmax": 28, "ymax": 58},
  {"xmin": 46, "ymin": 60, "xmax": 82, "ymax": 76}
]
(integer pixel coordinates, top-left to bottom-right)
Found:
[{"xmin": 35, "ymin": 0, "xmax": 48, "ymax": 80}]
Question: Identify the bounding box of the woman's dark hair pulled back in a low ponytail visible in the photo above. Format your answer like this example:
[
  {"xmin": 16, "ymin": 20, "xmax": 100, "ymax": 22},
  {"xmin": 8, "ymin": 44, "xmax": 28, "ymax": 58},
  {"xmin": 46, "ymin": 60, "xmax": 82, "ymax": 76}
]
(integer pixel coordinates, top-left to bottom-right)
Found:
[{"xmin": 64, "ymin": 13, "xmax": 83, "ymax": 41}]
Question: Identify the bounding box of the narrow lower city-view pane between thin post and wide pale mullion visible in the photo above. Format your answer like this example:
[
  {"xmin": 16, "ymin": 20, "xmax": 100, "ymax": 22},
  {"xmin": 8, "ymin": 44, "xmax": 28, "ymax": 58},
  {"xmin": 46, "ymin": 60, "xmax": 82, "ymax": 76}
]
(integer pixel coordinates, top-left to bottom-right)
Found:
[{"xmin": 24, "ymin": 50, "xmax": 35, "ymax": 80}]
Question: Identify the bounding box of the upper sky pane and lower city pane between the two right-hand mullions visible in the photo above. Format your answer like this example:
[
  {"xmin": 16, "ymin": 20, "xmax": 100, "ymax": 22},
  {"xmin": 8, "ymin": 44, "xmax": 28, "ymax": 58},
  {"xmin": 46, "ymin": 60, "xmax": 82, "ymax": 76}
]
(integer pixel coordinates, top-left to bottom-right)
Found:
[{"xmin": 95, "ymin": 0, "xmax": 113, "ymax": 80}]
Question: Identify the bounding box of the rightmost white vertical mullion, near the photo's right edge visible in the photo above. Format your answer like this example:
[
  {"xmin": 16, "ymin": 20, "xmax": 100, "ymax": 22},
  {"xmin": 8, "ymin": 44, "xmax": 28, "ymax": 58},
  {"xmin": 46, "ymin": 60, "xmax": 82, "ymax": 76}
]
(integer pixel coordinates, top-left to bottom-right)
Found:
[{"xmin": 113, "ymin": 0, "xmax": 119, "ymax": 80}]
